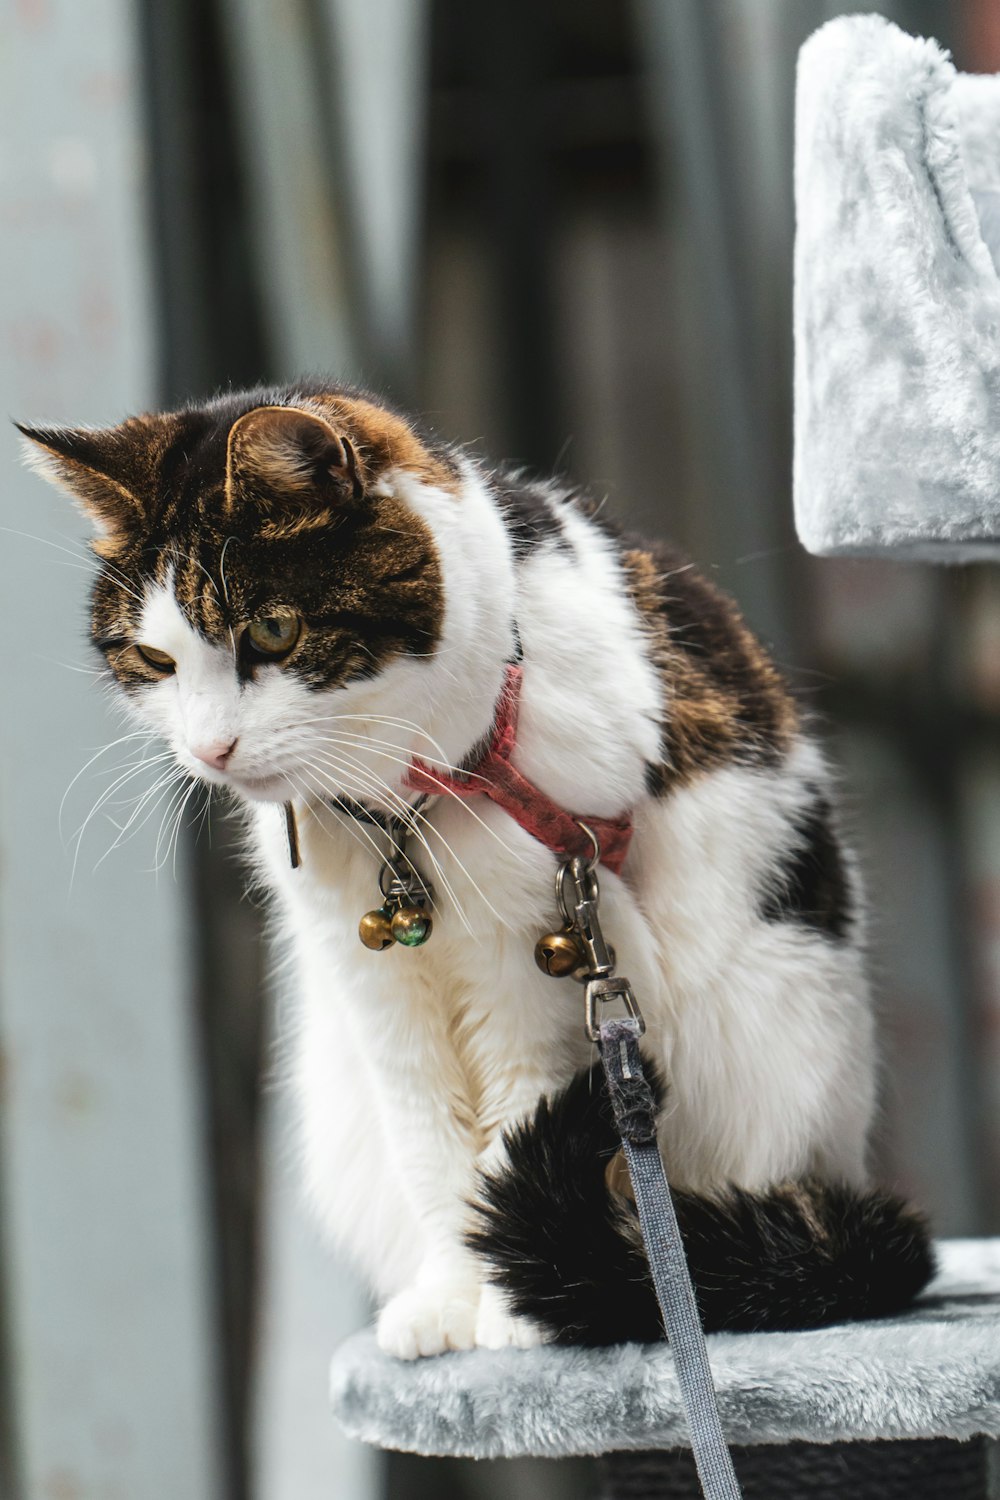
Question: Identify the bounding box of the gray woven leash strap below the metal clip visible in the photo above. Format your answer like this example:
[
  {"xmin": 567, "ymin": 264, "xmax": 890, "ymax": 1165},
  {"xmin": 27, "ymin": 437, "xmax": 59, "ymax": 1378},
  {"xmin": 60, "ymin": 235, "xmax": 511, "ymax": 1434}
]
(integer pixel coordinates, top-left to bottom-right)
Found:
[{"xmin": 598, "ymin": 1016, "xmax": 741, "ymax": 1500}]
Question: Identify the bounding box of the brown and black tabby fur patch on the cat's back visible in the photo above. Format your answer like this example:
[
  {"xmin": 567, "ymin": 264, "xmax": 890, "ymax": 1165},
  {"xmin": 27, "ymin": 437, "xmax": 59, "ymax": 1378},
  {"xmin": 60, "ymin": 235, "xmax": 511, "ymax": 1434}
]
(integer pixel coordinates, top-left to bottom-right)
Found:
[{"xmin": 622, "ymin": 545, "xmax": 798, "ymax": 792}]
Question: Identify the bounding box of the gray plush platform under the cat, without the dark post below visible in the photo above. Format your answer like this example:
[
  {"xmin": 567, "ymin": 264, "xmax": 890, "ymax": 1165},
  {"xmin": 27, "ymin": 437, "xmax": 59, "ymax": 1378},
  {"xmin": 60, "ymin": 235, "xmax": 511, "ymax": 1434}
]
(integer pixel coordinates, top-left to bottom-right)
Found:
[{"xmin": 331, "ymin": 1239, "xmax": 1000, "ymax": 1458}]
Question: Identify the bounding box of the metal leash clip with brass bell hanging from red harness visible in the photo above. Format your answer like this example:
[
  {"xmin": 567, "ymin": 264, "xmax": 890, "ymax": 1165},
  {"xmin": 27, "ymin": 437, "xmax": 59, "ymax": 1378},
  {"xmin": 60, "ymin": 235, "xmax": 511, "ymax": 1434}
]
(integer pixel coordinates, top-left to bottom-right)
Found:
[{"xmin": 535, "ymin": 824, "xmax": 646, "ymax": 1041}]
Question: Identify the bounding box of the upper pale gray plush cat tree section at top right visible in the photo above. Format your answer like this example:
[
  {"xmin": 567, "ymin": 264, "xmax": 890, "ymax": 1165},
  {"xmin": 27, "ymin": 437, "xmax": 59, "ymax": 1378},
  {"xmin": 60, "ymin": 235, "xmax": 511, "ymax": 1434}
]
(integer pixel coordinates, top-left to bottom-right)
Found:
[{"xmin": 795, "ymin": 15, "xmax": 1000, "ymax": 563}]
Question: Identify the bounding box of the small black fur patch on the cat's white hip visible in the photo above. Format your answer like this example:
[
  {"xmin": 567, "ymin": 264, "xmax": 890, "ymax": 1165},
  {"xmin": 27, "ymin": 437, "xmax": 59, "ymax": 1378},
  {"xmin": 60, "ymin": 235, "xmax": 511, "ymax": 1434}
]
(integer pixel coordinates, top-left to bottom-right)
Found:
[{"xmin": 760, "ymin": 794, "xmax": 853, "ymax": 938}]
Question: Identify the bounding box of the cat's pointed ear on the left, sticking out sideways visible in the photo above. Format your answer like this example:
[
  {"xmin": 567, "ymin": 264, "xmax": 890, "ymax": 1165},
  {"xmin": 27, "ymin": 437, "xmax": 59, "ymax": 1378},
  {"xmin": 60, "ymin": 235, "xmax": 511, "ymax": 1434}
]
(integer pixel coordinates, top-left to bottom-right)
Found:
[{"xmin": 15, "ymin": 417, "xmax": 153, "ymax": 537}]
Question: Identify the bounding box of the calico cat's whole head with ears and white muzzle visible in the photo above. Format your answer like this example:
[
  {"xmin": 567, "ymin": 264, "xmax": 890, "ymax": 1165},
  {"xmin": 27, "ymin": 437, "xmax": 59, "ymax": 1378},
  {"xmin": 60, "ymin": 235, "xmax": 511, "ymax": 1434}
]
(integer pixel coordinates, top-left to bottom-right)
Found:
[{"xmin": 21, "ymin": 390, "xmax": 459, "ymax": 801}]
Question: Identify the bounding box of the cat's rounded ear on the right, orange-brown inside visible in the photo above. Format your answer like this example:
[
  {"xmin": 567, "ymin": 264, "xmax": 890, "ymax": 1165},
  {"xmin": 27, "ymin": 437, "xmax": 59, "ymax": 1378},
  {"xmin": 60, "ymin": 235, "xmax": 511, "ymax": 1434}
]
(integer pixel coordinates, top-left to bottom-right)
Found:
[{"xmin": 226, "ymin": 407, "xmax": 364, "ymax": 507}]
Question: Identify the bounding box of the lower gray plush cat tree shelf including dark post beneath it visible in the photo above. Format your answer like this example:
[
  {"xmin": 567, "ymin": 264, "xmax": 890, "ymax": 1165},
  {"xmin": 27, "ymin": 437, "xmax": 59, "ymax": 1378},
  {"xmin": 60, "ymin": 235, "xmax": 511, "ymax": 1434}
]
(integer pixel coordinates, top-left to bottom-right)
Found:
[{"xmin": 331, "ymin": 1239, "xmax": 1000, "ymax": 1500}]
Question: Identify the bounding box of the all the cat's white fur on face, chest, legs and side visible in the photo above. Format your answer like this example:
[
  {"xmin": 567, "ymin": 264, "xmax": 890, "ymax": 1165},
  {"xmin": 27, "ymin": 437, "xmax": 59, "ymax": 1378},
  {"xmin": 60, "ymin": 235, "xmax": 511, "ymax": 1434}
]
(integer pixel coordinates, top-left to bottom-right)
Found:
[{"xmin": 113, "ymin": 468, "xmax": 873, "ymax": 1358}]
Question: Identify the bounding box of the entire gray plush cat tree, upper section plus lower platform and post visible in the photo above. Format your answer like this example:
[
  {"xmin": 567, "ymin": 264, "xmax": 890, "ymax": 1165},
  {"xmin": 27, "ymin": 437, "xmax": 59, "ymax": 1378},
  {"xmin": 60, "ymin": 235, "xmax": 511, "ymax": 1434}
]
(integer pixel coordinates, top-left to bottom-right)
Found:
[{"xmin": 331, "ymin": 17, "xmax": 1000, "ymax": 1500}]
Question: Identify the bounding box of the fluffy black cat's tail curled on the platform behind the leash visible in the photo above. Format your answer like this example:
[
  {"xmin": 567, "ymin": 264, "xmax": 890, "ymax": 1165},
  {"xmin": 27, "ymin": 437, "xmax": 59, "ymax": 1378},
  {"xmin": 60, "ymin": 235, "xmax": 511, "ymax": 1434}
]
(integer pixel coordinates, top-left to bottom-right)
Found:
[{"xmin": 469, "ymin": 1067, "xmax": 934, "ymax": 1344}]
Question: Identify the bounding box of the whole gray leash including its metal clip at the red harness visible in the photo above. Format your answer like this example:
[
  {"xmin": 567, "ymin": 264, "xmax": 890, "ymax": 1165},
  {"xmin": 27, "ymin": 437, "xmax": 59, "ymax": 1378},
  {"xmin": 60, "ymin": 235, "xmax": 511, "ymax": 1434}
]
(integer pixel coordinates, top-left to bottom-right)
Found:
[{"xmin": 554, "ymin": 858, "xmax": 741, "ymax": 1500}]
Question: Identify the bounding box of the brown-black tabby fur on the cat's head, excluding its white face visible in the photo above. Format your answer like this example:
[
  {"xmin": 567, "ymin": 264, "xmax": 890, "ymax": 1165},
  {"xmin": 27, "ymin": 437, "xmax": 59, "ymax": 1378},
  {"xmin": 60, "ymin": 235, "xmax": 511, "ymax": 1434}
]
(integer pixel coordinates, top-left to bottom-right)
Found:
[{"xmin": 22, "ymin": 387, "xmax": 457, "ymax": 687}]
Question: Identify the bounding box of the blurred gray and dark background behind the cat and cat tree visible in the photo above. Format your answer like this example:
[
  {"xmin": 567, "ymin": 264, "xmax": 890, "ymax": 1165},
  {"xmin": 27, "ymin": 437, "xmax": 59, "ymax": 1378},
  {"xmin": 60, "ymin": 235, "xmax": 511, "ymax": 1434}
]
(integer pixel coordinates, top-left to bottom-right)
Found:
[{"xmin": 0, "ymin": 0, "xmax": 1000, "ymax": 1500}]
